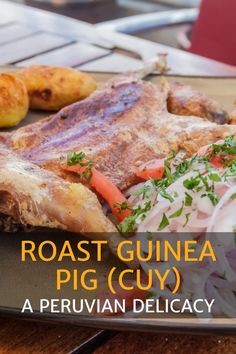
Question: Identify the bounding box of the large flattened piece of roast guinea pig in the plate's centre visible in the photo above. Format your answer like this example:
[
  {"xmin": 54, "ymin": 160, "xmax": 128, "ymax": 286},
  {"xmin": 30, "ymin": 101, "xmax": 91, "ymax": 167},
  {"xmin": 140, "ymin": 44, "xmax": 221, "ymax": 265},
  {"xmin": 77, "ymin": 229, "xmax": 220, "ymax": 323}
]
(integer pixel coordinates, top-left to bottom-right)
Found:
[{"xmin": 0, "ymin": 75, "xmax": 236, "ymax": 190}]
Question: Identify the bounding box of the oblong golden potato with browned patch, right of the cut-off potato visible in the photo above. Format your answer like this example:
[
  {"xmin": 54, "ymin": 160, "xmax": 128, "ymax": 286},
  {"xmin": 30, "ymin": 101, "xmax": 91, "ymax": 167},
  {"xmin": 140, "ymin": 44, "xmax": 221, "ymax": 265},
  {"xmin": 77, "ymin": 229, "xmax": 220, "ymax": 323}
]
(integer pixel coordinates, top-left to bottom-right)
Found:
[{"xmin": 17, "ymin": 65, "xmax": 96, "ymax": 111}]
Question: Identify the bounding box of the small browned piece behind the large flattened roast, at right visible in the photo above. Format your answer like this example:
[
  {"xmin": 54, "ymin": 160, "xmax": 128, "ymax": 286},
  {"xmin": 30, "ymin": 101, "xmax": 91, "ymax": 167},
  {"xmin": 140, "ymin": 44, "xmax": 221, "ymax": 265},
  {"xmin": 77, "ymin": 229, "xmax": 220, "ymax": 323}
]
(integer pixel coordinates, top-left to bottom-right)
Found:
[{"xmin": 167, "ymin": 82, "xmax": 229, "ymax": 124}]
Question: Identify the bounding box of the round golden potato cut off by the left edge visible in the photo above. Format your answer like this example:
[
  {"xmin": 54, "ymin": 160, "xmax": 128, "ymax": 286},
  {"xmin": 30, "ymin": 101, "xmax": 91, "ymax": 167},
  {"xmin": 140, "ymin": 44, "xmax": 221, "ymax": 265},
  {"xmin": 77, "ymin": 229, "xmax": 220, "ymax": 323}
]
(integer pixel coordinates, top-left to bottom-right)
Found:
[{"xmin": 0, "ymin": 74, "xmax": 29, "ymax": 128}]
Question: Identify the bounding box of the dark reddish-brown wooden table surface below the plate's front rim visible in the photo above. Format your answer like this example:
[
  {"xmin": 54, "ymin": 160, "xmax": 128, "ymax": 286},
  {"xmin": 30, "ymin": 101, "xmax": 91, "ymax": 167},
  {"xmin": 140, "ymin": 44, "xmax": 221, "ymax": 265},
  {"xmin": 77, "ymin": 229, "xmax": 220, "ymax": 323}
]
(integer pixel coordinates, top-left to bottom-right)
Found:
[{"xmin": 0, "ymin": 319, "xmax": 236, "ymax": 354}]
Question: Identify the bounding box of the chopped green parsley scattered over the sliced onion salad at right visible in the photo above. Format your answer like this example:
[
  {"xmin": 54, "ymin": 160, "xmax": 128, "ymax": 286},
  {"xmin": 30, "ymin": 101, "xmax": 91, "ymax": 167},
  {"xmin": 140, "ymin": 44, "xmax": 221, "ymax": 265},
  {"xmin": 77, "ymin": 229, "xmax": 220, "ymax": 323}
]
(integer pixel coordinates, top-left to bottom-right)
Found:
[{"xmin": 116, "ymin": 136, "xmax": 236, "ymax": 232}]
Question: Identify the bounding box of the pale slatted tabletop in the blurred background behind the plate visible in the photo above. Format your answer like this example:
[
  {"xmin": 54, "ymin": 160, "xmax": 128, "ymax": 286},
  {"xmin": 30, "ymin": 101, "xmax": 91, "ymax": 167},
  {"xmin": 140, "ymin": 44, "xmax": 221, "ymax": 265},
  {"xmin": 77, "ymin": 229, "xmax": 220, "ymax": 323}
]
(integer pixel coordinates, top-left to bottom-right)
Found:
[{"xmin": 0, "ymin": 0, "xmax": 236, "ymax": 76}]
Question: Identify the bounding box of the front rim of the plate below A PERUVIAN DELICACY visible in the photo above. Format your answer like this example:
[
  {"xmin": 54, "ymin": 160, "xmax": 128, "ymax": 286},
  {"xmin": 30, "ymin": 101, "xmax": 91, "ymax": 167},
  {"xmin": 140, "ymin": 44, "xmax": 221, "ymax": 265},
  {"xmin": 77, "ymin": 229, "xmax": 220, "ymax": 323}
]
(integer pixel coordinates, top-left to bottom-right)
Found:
[{"xmin": 0, "ymin": 307, "xmax": 236, "ymax": 335}]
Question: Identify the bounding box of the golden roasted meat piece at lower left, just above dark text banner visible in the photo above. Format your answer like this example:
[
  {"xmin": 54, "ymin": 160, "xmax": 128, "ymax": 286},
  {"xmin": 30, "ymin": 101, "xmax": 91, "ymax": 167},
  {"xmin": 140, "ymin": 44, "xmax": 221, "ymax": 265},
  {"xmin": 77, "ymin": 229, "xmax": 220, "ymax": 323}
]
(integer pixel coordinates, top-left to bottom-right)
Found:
[{"xmin": 0, "ymin": 145, "xmax": 115, "ymax": 233}]
